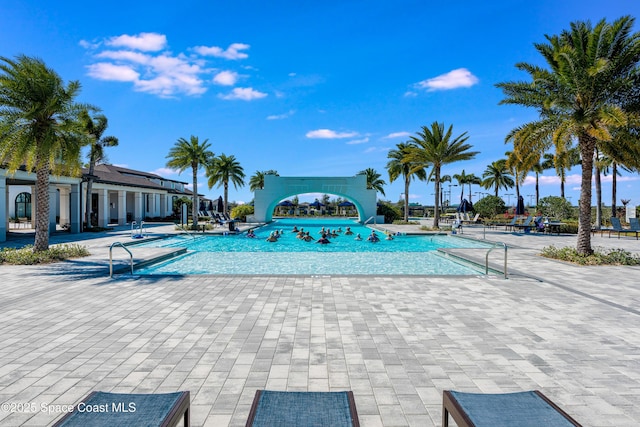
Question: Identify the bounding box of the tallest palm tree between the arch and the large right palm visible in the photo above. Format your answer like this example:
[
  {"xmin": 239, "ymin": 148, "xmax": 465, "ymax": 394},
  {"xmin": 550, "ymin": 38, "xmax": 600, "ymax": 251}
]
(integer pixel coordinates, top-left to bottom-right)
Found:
[{"xmin": 409, "ymin": 122, "xmax": 478, "ymax": 228}]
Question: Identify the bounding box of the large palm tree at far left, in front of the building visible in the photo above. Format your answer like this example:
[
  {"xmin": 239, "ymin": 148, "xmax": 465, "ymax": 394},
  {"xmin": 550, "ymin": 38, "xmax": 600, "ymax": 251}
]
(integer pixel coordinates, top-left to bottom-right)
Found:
[{"xmin": 0, "ymin": 55, "xmax": 93, "ymax": 252}]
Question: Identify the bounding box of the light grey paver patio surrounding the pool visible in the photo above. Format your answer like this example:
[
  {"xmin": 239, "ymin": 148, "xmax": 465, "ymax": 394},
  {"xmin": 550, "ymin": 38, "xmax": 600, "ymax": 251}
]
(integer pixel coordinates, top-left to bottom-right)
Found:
[{"xmin": 0, "ymin": 227, "xmax": 640, "ymax": 426}]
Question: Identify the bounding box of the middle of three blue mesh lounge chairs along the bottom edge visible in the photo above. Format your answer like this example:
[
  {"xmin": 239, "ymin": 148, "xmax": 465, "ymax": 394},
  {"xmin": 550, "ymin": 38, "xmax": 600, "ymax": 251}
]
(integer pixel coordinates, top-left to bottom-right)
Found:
[{"xmin": 246, "ymin": 390, "xmax": 360, "ymax": 427}]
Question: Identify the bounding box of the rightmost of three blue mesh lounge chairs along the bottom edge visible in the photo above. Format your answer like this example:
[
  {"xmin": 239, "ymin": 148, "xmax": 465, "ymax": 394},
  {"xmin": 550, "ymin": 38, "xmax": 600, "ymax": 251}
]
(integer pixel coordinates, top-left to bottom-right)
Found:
[{"xmin": 442, "ymin": 390, "xmax": 581, "ymax": 427}]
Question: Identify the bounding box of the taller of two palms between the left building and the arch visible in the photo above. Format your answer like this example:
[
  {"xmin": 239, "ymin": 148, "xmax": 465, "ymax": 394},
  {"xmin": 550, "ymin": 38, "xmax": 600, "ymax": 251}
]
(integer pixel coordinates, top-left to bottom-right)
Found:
[{"xmin": 166, "ymin": 135, "xmax": 214, "ymax": 228}]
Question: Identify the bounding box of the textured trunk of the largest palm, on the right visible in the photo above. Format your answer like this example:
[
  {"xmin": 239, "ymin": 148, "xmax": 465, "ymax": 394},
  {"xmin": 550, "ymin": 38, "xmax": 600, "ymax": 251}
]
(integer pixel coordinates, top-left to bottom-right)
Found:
[{"xmin": 576, "ymin": 134, "xmax": 596, "ymax": 256}]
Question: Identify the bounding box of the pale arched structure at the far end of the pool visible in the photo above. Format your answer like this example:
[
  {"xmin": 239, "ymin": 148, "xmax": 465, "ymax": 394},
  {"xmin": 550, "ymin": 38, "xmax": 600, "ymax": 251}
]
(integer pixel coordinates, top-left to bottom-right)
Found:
[{"xmin": 250, "ymin": 175, "xmax": 377, "ymax": 226}]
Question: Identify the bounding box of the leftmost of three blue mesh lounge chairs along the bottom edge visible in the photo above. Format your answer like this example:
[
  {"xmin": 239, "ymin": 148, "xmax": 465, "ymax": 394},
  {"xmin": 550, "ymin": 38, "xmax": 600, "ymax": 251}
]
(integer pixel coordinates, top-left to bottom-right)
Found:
[{"xmin": 54, "ymin": 391, "xmax": 190, "ymax": 427}]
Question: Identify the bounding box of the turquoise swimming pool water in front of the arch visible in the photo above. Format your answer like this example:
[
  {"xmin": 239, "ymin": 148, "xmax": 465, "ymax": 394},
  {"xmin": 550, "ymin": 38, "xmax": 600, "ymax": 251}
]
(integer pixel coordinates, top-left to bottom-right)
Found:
[{"xmin": 132, "ymin": 219, "xmax": 486, "ymax": 275}]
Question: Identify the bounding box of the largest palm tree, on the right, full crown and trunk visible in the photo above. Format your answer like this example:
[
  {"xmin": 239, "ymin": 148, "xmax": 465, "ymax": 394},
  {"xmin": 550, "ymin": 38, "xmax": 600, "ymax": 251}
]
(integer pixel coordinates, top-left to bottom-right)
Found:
[{"xmin": 497, "ymin": 16, "xmax": 640, "ymax": 255}]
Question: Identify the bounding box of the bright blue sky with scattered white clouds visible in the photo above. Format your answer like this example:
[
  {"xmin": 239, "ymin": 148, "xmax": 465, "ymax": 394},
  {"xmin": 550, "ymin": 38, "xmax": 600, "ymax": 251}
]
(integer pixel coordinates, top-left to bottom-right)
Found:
[{"xmin": 0, "ymin": 0, "xmax": 640, "ymax": 204}]
